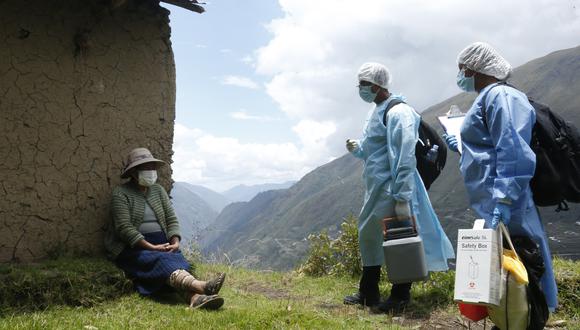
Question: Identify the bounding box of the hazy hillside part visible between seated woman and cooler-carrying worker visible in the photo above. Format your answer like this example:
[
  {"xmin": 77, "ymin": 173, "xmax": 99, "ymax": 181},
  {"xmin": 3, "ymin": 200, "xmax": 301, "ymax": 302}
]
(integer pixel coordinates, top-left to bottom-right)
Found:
[{"xmin": 200, "ymin": 155, "xmax": 362, "ymax": 268}]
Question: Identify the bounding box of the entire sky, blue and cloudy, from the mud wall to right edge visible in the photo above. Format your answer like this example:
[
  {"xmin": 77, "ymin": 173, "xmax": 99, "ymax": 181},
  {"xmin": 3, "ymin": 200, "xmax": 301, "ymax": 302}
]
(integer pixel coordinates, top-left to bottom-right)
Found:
[{"xmin": 164, "ymin": 0, "xmax": 580, "ymax": 191}]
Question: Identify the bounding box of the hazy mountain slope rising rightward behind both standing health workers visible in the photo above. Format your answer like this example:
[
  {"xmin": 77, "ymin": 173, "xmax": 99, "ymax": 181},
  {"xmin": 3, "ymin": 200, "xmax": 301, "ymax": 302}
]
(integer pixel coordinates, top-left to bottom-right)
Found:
[{"xmin": 201, "ymin": 47, "xmax": 580, "ymax": 269}]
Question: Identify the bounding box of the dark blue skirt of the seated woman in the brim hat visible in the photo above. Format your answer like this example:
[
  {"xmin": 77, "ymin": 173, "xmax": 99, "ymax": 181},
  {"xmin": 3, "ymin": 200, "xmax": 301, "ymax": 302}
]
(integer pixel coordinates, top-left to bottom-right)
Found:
[{"xmin": 115, "ymin": 232, "xmax": 190, "ymax": 296}]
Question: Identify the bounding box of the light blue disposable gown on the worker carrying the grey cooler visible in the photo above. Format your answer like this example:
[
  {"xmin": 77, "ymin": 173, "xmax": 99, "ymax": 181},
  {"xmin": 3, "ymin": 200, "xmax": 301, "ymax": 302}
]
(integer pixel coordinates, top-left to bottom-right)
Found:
[{"xmin": 353, "ymin": 96, "xmax": 455, "ymax": 271}]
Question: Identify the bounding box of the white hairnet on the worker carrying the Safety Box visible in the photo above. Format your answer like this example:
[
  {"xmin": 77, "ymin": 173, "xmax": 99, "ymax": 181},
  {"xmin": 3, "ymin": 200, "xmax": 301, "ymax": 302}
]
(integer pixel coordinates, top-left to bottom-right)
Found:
[{"xmin": 457, "ymin": 42, "xmax": 512, "ymax": 80}]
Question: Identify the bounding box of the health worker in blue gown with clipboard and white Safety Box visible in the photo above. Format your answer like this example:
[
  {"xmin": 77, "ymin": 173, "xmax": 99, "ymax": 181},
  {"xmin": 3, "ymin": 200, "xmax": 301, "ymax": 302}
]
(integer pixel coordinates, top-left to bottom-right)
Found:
[{"xmin": 444, "ymin": 42, "xmax": 558, "ymax": 312}]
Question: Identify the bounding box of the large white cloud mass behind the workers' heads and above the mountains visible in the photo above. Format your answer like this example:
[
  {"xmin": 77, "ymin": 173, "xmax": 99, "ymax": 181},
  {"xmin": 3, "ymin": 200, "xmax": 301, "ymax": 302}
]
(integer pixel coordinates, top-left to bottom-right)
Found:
[{"xmin": 174, "ymin": 0, "xmax": 580, "ymax": 189}]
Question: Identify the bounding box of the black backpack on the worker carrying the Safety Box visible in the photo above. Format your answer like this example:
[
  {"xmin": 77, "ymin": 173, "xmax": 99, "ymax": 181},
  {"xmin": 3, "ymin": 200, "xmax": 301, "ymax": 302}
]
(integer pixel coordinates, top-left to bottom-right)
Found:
[{"xmin": 482, "ymin": 83, "xmax": 580, "ymax": 212}]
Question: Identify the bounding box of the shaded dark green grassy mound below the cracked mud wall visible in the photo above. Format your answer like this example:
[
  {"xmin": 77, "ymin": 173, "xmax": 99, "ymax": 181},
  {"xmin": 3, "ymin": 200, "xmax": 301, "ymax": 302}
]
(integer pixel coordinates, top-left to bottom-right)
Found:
[{"xmin": 0, "ymin": 258, "xmax": 133, "ymax": 316}]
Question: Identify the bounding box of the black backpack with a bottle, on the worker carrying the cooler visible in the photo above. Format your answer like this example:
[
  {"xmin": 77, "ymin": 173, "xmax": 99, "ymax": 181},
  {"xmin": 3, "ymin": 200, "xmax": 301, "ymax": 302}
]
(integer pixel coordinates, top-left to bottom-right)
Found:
[{"xmin": 383, "ymin": 99, "xmax": 447, "ymax": 189}]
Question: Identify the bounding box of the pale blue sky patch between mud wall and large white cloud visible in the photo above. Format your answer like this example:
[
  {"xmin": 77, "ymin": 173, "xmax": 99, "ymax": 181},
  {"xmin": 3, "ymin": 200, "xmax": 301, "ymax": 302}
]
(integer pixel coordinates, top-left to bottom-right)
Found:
[{"xmin": 167, "ymin": 0, "xmax": 292, "ymax": 142}]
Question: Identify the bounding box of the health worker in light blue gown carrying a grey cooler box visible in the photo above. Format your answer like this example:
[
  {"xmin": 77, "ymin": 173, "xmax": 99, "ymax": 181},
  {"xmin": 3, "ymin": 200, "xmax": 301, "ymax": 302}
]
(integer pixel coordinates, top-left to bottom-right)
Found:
[{"xmin": 344, "ymin": 63, "xmax": 455, "ymax": 312}]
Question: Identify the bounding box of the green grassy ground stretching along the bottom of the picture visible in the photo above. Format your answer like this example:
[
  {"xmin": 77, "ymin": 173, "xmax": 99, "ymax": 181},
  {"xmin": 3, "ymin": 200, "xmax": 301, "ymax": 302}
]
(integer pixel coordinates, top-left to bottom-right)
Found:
[{"xmin": 0, "ymin": 259, "xmax": 580, "ymax": 330}]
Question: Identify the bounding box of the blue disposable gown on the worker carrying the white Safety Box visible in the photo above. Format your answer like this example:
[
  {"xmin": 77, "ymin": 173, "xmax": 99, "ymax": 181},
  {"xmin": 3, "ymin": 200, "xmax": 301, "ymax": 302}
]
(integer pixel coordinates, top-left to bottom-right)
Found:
[{"xmin": 460, "ymin": 84, "xmax": 558, "ymax": 311}]
